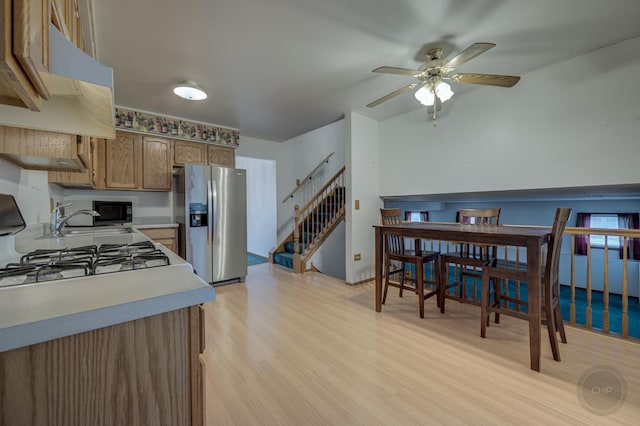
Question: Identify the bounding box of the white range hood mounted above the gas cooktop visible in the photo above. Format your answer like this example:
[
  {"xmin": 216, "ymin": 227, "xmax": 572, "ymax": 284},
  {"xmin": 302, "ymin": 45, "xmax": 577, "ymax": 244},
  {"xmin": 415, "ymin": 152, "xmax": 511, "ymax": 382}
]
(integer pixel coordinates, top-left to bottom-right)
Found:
[{"xmin": 0, "ymin": 25, "xmax": 115, "ymax": 139}]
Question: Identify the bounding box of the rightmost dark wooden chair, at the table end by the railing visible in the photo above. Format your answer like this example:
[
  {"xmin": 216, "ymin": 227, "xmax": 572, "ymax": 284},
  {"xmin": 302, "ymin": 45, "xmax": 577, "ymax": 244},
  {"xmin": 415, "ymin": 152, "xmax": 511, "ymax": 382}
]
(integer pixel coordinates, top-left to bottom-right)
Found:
[{"xmin": 480, "ymin": 207, "xmax": 571, "ymax": 361}]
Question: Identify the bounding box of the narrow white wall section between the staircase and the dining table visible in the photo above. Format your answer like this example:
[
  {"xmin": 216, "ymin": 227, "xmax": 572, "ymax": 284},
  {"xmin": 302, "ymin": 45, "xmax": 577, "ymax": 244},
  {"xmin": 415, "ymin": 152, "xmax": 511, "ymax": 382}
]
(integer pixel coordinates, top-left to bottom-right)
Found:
[{"xmin": 345, "ymin": 112, "xmax": 382, "ymax": 283}]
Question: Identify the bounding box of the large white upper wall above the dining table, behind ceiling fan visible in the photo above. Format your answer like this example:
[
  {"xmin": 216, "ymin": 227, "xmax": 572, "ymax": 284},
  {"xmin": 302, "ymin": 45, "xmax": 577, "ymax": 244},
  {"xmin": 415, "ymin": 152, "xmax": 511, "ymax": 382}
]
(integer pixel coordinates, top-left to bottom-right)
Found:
[{"xmin": 380, "ymin": 37, "xmax": 640, "ymax": 195}]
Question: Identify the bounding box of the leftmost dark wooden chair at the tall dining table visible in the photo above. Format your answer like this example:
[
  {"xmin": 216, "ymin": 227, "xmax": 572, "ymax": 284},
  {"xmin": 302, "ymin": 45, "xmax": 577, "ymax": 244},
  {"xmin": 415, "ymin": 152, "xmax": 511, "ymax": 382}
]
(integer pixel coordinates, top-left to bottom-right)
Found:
[{"xmin": 380, "ymin": 208, "xmax": 442, "ymax": 318}]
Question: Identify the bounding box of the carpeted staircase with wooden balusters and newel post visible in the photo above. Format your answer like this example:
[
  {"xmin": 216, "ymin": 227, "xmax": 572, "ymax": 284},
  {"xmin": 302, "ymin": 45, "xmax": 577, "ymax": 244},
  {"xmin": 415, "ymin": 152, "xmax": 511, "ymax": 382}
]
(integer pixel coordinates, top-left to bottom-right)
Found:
[{"xmin": 269, "ymin": 167, "xmax": 346, "ymax": 273}]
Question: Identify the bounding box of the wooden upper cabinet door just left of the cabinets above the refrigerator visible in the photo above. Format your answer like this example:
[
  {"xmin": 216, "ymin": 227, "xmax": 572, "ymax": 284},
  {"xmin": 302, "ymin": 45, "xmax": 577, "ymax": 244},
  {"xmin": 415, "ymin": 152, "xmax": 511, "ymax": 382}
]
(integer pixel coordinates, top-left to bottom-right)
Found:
[{"xmin": 142, "ymin": 137, "xmax": 172, "ymax": 191}]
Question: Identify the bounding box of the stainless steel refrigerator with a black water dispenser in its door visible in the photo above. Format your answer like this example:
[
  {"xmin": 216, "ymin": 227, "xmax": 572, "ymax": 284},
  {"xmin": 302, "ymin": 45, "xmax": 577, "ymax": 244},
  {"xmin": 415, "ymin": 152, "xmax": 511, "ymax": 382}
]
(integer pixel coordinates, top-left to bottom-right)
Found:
[{"xmin": 174, "ymin": 164, "xmax": 247, "ymax": 284}]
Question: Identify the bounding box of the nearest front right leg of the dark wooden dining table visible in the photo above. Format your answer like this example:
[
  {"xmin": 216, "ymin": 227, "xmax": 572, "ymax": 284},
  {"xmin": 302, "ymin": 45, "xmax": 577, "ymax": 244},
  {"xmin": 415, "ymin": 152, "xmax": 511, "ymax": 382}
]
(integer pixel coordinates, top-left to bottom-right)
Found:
[{"xmin": 527, "ymin": 242, "xmax": 541, "ymax": 371}]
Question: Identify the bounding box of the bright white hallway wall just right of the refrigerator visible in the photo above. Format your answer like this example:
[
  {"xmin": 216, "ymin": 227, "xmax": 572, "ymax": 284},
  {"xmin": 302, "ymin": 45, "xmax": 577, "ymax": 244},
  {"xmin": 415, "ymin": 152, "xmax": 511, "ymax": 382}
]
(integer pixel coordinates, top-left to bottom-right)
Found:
[{"xmin": 236, "ymin": 156, "xmax": 278, "ymax": 257}]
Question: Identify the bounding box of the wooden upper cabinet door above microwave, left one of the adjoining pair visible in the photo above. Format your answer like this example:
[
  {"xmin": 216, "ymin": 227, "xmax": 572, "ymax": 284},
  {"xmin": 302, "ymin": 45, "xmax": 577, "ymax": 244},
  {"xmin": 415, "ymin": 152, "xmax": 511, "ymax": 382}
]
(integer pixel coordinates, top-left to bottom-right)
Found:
[{"xmin": 105, "ymin": 133, "xmax": 141, "ymax": 189}]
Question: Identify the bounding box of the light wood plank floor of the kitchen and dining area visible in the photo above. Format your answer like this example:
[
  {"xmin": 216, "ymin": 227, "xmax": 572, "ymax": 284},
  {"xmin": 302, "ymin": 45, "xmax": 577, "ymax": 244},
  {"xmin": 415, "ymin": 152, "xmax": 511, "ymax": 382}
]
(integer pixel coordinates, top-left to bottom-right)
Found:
[{"xmin": 204, "ymin": 264, "xmax": 640, "ymax": 425}]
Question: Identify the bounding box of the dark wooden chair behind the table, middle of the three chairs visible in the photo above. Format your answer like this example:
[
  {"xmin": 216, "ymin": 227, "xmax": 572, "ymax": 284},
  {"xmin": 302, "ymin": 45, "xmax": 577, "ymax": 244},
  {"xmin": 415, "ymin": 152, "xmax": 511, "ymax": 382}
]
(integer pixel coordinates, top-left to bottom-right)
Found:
[{"xmin": 440, "ymin": 208, "xmax": 500, "ymax": 312}]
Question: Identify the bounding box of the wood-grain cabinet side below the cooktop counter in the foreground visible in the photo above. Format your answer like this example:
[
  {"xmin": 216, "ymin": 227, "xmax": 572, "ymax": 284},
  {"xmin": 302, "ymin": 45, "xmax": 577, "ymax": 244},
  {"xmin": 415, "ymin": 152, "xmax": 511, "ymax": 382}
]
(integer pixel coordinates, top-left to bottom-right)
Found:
[{"xmin": 0, "ymin": 306, "xmax": 204, "ymax": 426}]
